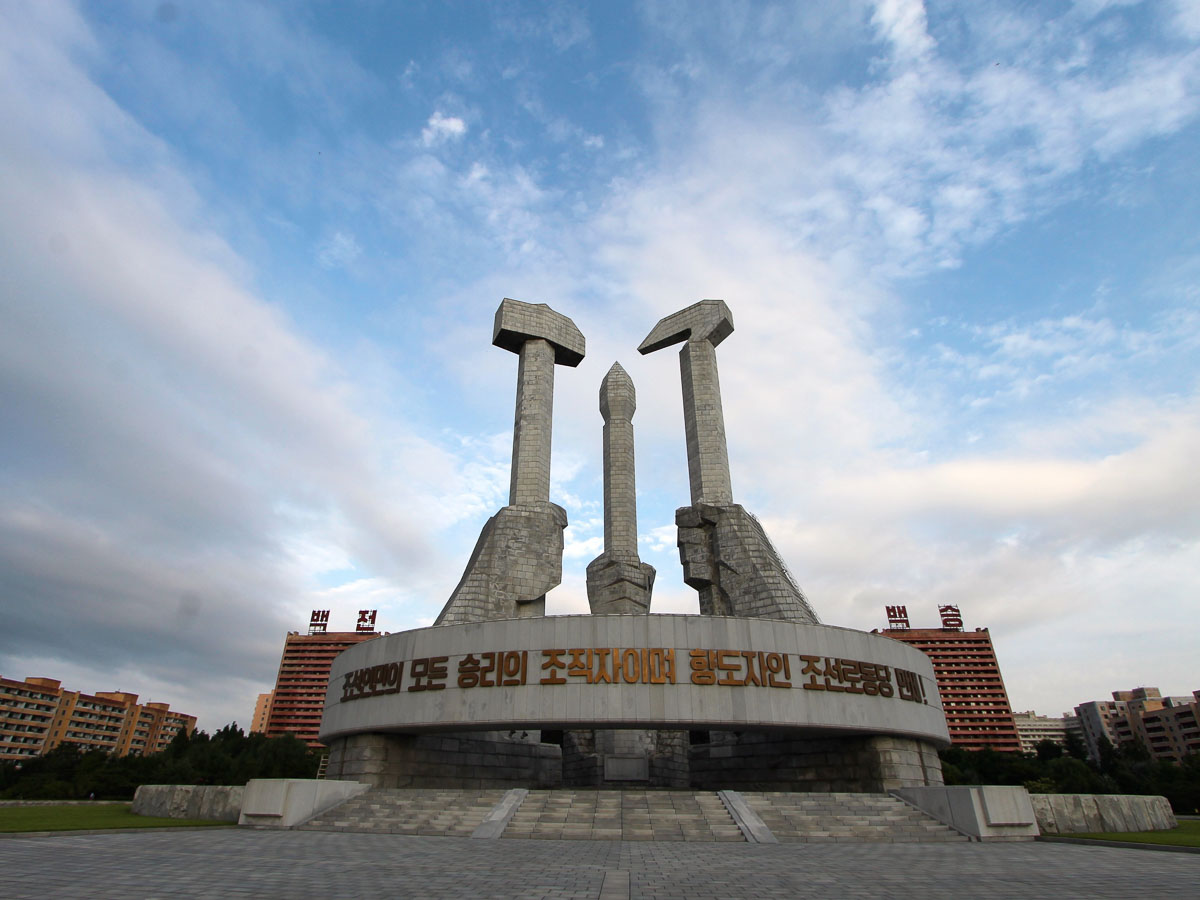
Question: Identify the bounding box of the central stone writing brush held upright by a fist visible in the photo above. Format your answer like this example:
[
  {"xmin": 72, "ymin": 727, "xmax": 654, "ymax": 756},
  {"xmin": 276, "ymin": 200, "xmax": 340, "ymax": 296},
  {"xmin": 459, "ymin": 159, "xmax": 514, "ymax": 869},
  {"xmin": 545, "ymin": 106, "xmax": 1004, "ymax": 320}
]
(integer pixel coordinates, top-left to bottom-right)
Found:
[{"xmin": 587, "ymin": 362, "xmax": 655, "ymax": 614}]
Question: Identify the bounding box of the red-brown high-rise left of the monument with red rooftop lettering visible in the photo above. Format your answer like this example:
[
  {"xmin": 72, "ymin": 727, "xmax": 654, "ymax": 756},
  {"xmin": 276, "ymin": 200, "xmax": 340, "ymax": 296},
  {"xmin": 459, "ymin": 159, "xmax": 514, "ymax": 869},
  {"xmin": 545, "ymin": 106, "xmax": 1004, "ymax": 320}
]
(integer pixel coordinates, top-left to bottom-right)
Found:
[{"xmin": 265, "ymin": 610, "xmax": 379, "ymax": 749}]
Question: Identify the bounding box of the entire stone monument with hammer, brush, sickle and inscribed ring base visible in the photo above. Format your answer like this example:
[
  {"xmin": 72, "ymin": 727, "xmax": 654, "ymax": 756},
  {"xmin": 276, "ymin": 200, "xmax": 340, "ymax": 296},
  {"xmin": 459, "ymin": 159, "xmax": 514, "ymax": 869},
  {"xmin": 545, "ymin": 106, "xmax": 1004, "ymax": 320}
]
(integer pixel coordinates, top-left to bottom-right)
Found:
[{"xmin": 320, "ymin": 299, "xmax": 949, "ymax": 791}]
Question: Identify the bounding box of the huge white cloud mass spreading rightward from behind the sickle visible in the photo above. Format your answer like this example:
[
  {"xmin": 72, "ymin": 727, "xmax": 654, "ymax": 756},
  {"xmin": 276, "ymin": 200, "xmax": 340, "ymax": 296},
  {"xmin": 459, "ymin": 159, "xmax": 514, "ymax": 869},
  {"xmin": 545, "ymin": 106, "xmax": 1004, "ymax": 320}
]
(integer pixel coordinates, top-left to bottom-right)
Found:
[{"xmin": 568, "ymin": 5, "xmax": 1200, "ymax": 712}]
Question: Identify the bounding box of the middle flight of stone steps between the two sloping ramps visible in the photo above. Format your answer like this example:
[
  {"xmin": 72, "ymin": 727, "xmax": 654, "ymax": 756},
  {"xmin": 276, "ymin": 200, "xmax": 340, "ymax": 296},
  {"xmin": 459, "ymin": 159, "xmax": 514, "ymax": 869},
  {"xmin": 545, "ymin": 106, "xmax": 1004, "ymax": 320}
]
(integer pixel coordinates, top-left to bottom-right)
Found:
[{"xmin": 503, "ymin": 790, "xmax": 745, "ymax": 841}]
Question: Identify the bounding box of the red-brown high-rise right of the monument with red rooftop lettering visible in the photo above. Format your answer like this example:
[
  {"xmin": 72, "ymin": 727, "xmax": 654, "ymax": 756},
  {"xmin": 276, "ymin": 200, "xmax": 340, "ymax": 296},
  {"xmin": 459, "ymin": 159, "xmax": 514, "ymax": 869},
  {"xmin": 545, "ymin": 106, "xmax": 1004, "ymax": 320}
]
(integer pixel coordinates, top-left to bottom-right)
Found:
[{"xmin": 880, "ymin": 606, "xmax": 1021, "ymax": 752}]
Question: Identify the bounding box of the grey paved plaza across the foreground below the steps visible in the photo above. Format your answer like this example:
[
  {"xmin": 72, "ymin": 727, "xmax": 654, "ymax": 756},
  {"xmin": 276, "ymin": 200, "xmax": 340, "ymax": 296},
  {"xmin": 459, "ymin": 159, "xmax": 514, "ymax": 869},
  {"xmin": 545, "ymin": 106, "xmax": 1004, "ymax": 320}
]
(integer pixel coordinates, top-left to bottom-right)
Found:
[{"xmin": 0, "ymin": 828, "xmax": 1200, "ymax": 900}]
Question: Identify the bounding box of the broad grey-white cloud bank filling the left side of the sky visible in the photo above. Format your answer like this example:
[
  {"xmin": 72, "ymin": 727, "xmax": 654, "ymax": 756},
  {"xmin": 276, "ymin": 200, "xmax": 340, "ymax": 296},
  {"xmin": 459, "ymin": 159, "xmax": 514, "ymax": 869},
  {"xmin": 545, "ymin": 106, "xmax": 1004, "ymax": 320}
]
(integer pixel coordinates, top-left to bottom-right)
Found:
[{"xmin": 0, "ymin": 3, "xmax": 472, "ymax": 727}]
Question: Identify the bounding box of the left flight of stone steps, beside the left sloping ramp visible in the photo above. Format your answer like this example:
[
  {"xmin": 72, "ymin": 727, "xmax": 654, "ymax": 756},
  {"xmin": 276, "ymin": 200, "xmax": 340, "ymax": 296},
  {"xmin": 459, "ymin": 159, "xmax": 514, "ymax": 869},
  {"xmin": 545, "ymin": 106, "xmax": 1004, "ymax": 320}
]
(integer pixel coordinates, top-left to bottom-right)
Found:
[{"xmin": 299, "ymin": 788, "xmax": 504, "ymax": 838}]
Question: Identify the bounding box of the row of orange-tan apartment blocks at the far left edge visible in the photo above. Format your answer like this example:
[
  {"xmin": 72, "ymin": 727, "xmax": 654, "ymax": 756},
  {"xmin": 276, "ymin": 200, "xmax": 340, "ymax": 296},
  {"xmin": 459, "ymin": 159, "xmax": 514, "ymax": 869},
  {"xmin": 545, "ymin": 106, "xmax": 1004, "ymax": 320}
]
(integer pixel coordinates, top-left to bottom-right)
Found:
[{"xmin": 0, "ymin": 678, "xmax": 196, "ymax": 760}]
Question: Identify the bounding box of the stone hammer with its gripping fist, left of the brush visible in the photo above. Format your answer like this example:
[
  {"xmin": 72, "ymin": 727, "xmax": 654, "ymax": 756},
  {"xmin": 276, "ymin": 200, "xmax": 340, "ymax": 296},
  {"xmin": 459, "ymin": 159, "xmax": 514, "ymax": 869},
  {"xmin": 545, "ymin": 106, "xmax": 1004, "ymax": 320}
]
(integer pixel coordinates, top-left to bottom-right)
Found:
[{"xmin": 433, "ymin": 299, "xmax": 584, "ymax": 625}]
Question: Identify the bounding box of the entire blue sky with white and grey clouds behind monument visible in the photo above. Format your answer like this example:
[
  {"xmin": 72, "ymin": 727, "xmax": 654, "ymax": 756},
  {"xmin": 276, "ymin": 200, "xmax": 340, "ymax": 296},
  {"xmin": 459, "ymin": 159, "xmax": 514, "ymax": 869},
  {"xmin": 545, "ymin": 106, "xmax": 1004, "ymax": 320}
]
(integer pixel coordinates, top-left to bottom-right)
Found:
[{"xmin": 0, "ymin": 0, "xmax": 1200, "ymax": 730}]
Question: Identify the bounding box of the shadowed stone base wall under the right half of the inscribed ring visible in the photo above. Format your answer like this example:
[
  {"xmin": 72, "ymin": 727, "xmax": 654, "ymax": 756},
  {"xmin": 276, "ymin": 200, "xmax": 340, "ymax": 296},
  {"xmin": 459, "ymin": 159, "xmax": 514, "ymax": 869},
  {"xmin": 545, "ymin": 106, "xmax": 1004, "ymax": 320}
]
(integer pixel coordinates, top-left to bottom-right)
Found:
[{"xmin": 689, "ymin": 731, "xmax": 942, "ymax": 793}]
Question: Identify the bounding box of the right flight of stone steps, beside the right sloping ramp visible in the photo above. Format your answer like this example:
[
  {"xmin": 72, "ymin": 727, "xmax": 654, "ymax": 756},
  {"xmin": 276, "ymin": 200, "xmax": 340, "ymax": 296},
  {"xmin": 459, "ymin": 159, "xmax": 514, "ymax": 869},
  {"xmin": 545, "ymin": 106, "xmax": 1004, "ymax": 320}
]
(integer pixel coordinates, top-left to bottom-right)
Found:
[{"xmin": 742, "ymin": 791, "xmax": 971, "ymax": 844}]
